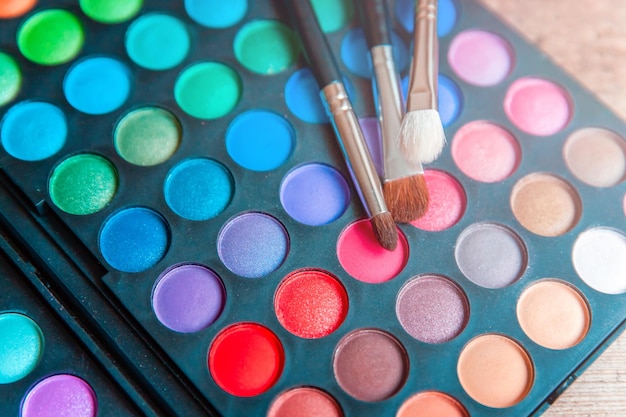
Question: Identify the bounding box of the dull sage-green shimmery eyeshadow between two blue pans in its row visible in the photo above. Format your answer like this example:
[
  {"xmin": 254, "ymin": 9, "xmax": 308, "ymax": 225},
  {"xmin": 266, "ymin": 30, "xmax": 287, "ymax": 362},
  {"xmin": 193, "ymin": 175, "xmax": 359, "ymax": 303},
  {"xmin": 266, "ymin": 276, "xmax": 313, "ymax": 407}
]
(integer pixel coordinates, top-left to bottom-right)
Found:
[{"xmin": 113, "ymin": 107, "xmax": 182, "ymax": 166}]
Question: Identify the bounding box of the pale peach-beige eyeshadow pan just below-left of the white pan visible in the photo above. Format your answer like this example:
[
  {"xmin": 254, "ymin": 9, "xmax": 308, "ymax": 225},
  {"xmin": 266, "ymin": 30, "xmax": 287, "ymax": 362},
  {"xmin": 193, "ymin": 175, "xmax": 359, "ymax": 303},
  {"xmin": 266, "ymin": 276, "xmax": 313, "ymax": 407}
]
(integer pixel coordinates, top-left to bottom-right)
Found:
[{"xmin": 517, "ymin": 279, "xmax": 591, "ymax": 349}]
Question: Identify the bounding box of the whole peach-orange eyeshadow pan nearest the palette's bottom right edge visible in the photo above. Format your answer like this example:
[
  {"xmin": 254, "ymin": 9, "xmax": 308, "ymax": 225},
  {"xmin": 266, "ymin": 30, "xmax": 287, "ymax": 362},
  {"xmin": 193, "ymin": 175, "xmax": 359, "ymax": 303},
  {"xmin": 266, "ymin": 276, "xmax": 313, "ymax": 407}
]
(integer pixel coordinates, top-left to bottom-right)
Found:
[{"xmin": 457, "ymin": 333, "xmax": 535, "ymax": 408}]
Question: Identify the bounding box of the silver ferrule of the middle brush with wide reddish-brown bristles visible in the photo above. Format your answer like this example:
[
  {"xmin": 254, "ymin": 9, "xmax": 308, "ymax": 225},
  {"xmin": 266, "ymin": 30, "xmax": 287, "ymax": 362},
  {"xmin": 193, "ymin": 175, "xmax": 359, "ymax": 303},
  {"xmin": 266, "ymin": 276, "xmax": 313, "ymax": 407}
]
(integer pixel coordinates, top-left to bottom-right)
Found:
[{"xmin": 370, "ymin": 45, "xmax": 424, "ymax": 181}]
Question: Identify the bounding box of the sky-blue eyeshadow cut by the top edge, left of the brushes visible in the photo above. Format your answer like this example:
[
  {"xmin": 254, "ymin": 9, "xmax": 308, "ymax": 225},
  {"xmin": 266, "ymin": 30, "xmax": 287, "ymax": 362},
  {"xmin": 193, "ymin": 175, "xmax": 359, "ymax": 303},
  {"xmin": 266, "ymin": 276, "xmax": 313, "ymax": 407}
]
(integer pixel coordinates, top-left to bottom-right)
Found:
[{"xmin": 185, "ymin": 0, "xmax": 248, "ymax": 29}]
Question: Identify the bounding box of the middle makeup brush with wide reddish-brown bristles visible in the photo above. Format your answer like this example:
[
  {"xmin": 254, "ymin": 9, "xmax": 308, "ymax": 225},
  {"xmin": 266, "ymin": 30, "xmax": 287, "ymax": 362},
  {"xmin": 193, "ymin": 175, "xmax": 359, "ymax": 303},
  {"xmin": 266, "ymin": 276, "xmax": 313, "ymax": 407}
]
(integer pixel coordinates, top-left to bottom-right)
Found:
[{"xmin": 361, "ymin": 0, "xmax": 428, "ymax": 223}]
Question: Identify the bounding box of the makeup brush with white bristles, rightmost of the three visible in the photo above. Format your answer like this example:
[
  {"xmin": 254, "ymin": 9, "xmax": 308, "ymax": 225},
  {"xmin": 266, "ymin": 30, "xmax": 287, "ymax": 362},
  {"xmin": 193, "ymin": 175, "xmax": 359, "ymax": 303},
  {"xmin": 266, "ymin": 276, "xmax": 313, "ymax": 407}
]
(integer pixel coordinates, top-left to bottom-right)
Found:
[{"xmin": 399, "ymin": 0, "xmax": 446, "ymax": 163}]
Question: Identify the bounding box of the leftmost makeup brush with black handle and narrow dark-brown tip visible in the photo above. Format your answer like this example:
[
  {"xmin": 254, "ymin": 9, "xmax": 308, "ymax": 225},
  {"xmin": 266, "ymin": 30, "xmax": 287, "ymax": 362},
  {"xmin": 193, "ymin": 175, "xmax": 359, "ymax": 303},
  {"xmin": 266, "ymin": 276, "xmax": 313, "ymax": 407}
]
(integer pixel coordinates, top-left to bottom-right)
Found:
[{"xmin": 282, "ymin": 0, "xmax": 398, "ymax": 250}]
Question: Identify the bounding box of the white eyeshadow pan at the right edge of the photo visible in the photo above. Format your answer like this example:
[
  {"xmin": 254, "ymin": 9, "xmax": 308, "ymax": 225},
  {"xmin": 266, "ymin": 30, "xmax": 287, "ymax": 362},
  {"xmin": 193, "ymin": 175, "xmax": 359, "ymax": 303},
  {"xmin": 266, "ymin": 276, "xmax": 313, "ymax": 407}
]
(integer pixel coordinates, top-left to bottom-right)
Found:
[{"xmin": 572, "ymin": 227, "xmax": 626, "ymax": 294}]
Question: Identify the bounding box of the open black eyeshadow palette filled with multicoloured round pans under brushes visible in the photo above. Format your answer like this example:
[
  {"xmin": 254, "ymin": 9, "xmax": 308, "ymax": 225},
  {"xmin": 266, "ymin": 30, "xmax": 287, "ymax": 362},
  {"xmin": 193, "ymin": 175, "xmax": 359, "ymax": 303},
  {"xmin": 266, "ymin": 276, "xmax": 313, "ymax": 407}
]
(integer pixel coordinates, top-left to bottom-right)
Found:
[{"xmin": 0, "ymin": 0, "xmax": 626, "ymax": 417}]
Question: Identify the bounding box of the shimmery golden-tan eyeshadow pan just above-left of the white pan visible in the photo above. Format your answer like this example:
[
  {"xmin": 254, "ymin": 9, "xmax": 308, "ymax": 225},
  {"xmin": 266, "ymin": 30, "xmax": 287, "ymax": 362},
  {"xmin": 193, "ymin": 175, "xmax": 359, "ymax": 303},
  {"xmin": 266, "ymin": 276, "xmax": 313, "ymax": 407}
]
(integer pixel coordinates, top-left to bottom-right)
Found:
[{"xmin": 511, "ymin": 173, "xmax": 582, "ymax": 237}]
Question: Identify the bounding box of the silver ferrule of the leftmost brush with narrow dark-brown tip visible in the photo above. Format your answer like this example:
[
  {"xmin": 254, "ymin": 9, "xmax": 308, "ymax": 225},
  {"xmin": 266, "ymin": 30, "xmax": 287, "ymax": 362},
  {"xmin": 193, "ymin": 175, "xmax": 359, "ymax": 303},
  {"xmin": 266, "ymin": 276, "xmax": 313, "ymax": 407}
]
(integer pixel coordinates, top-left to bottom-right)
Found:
[{"xmin": 320, "ymin": 82, "xmax": 389, "ymax": 217}]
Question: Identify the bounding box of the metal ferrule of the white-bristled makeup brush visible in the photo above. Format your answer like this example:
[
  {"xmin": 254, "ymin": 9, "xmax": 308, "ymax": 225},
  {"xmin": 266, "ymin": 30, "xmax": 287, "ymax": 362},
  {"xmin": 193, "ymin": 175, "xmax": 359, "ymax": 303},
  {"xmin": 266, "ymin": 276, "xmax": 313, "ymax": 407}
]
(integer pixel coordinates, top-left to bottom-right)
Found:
[{"xmin": 406, "ymin": 0, "xmax": 439, "ymax": 113}]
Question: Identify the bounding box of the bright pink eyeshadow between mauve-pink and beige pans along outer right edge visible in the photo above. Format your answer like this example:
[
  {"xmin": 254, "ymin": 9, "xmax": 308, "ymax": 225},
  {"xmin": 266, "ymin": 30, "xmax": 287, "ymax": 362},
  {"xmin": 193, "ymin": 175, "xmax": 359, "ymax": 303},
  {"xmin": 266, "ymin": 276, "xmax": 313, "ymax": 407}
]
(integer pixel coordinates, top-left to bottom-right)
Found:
[{"xmin": 504, "ymin": 77, "xmax": 572, "ymax": 136}]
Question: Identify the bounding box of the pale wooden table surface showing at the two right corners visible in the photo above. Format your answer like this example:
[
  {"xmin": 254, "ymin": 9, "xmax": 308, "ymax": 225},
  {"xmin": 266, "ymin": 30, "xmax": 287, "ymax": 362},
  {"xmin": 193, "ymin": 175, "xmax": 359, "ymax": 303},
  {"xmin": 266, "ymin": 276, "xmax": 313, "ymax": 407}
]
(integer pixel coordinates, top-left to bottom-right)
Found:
[{"xmin": 472, "ymin": 0, "xmax": 626, "ymax": 417}]
